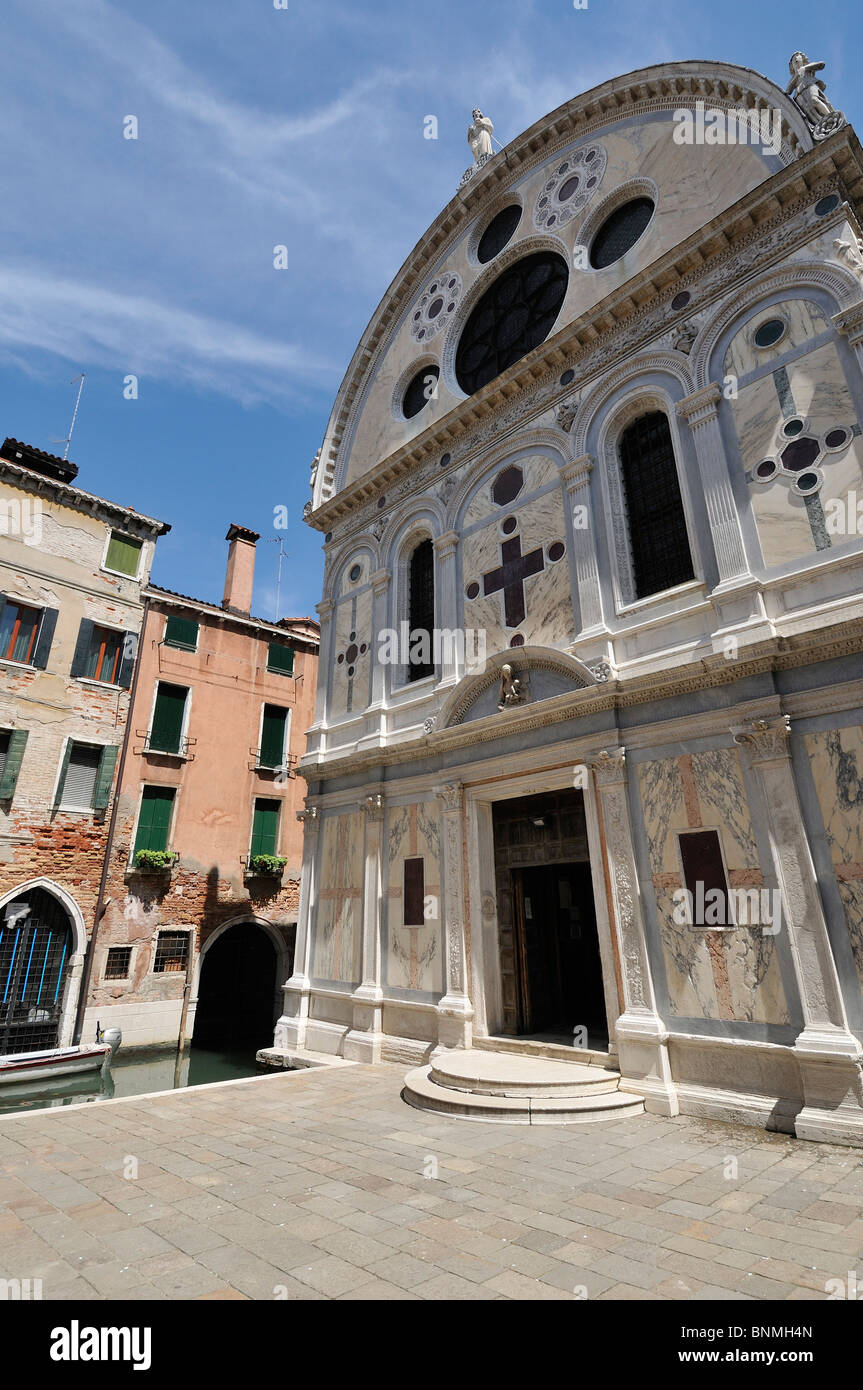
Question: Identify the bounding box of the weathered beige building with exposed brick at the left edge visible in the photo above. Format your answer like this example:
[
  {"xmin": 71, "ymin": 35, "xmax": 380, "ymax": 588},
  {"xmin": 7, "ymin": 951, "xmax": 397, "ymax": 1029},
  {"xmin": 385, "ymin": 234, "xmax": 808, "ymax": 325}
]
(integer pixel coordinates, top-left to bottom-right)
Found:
[{"xmin": 0, "ymin": 439, "xmax": 170, "ymax": 1052}]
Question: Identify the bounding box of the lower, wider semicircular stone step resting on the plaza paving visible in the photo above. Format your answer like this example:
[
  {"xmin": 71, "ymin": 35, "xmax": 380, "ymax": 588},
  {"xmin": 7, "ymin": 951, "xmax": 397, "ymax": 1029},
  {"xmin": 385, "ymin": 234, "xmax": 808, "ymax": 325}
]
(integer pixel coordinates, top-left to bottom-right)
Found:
[{"xmin": 402, "ymin": 1063, "xmax": 645, "ymax": 1125}]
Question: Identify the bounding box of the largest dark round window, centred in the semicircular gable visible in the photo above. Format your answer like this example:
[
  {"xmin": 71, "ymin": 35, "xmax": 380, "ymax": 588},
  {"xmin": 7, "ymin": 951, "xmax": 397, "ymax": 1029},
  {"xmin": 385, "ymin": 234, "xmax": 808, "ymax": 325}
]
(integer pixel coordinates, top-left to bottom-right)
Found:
[{"xmin": 453, "ymin": 252, "xmax": 570, "ymax": 396}]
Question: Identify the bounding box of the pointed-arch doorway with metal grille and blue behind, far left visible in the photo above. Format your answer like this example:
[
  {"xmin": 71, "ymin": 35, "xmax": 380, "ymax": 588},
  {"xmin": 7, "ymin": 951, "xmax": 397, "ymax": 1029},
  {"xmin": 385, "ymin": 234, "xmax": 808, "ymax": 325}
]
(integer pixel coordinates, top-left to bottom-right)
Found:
[{"xmin": 0, "ymin": 888, "xmax": 74, "ymax": 1054}]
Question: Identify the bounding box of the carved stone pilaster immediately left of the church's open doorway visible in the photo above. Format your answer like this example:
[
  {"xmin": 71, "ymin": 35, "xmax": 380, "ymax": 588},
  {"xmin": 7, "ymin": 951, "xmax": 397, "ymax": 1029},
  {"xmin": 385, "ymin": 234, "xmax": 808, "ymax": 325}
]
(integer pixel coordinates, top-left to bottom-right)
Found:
[{"xmin": 435, "ymin": 783, "xmax": 474, "ymax": 1047}]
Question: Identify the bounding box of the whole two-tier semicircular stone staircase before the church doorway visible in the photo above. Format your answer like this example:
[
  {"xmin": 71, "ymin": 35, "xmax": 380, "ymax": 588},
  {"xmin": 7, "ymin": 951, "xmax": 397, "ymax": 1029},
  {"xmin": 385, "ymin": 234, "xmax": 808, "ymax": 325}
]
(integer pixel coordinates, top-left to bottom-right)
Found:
[{"xmin": 402, "ymin": 1038, "xmax": 645, "ymax": 1125}]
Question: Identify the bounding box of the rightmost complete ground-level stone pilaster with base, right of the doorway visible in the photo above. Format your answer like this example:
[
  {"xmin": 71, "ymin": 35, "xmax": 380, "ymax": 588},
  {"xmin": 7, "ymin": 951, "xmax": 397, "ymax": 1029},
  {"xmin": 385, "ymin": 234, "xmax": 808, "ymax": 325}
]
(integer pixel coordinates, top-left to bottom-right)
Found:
[{"xmin": 731, "ymin": 714, "xmax": 863, "ymax": 1144}]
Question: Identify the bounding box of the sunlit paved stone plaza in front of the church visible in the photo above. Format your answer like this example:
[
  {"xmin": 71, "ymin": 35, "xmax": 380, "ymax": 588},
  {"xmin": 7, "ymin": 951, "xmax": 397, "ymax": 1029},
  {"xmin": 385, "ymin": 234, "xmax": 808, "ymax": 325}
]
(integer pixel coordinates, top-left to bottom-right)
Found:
[{"xmin": 0, "ymin": 1065, "xmax": 863, "ymax": 1300}]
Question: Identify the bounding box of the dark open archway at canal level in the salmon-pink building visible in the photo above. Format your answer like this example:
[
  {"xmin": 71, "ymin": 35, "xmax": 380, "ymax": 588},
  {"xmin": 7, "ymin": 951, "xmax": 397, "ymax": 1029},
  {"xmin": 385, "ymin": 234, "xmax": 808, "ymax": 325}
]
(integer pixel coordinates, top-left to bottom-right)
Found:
[{"xmin": 192, "ymin": 922, "xmax": 277, "ymax": 1049}]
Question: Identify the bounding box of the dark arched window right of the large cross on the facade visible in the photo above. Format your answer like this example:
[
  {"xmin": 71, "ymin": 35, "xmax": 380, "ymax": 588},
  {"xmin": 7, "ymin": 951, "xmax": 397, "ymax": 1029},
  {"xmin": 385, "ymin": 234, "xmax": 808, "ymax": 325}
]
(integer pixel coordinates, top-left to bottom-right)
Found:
[{"xmin": 620, "ymin": 410, "xmax": 695, "ymax": 599}]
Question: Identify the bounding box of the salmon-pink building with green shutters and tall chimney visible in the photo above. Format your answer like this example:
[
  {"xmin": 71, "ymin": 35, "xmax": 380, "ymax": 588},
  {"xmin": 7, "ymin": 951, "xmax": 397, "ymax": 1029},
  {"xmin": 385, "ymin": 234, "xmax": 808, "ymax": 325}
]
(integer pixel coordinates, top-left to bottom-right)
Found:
[{"xmin": 85, "ymin": 525, "xmax": 320, "ymax": 1047}]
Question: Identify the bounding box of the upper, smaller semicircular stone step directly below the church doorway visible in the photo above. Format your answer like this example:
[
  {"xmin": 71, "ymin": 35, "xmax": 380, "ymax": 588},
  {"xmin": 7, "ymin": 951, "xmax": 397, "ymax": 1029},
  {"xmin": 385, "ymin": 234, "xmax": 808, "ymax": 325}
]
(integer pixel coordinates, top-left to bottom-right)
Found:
[{"xmin": 429, "ymin": 1048, "xmax": 620, "ymax": 1098}]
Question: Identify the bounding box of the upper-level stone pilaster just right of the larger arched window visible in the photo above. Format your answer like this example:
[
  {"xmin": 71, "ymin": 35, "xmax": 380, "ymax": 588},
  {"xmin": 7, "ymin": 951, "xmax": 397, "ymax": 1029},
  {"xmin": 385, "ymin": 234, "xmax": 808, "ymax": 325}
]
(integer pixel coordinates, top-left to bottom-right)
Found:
[{"xmin": 677, "ymin": 381, "xmax": 750, "ymax": 589}]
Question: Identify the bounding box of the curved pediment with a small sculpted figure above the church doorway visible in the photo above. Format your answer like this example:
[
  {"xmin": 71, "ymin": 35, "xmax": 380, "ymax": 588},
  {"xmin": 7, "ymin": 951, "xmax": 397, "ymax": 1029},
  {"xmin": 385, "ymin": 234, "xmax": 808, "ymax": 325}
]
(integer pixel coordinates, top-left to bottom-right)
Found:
[{"xmin": 441, "ymin": 646, "xmax": 610, "ymax": 728}]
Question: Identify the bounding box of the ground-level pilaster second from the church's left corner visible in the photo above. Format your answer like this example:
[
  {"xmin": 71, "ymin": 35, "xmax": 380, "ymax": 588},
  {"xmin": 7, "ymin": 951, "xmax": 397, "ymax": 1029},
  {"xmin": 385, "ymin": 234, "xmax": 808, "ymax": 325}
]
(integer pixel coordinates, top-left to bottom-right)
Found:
[{"xmin": 345, "ymin": 792, "xmax": 385, "ymax": 1062}]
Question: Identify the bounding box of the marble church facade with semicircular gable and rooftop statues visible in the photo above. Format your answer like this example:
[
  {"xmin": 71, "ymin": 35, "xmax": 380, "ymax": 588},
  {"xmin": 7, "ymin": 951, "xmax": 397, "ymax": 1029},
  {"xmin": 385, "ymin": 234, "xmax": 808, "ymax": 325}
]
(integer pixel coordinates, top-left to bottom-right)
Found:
[{"xmin": 271, "ymin": 54, "xmax": 863, "ymax": 1144}]
